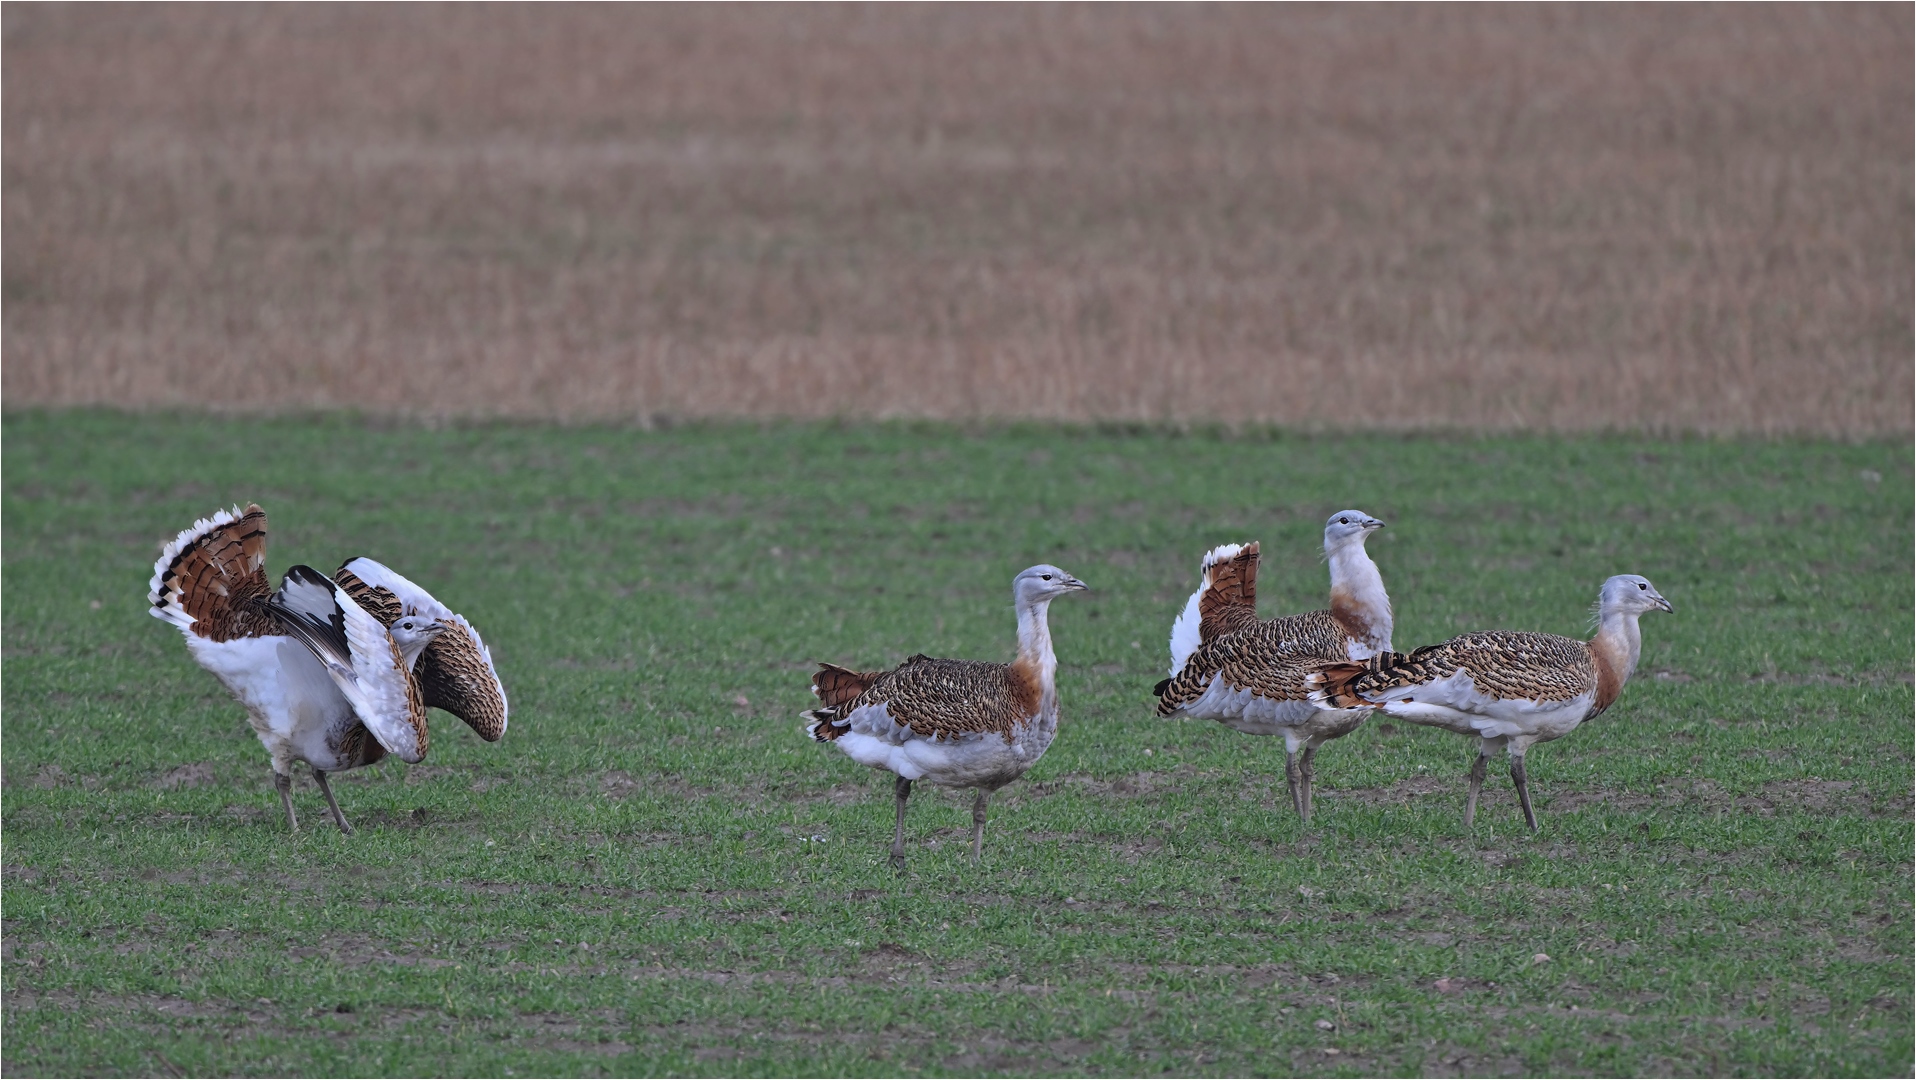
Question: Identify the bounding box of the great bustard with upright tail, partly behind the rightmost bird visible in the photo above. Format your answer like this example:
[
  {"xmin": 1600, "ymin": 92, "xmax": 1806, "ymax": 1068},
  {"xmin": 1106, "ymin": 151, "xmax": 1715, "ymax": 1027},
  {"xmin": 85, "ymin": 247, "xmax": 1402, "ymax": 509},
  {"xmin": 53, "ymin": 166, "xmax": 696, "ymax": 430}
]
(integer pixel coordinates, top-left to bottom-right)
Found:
[{"xmin": 1155, "ymin": 509, "xmax": 1391, "ymax": 821}]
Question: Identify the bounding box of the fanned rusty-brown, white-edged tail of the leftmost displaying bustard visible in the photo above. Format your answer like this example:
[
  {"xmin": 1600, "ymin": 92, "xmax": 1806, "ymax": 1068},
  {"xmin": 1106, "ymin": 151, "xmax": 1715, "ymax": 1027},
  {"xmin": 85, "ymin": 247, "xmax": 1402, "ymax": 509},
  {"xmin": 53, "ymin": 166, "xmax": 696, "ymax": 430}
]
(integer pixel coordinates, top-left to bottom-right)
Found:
[{"xmin": 159, "ymin": 504, "xmax": 280, "ymax": 641}]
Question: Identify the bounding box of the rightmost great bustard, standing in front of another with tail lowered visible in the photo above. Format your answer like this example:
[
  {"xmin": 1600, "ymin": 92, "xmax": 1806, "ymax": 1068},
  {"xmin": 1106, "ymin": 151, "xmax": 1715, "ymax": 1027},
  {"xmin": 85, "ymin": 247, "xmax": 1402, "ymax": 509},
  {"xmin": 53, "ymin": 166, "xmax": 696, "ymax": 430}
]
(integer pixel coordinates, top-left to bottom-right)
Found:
[{"xmin": 1311, "ymin": 574, "xmax": 1675, "ymax": 833}]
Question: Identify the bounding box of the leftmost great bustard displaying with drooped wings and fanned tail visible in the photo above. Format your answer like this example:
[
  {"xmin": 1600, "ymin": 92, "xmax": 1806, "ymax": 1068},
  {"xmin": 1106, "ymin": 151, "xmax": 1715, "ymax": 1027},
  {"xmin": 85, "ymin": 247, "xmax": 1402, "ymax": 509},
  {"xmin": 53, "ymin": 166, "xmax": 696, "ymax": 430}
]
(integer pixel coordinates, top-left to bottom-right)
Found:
[{"xmin": 148, "ymin": 506, "xmax": 506, "ymax": 833}]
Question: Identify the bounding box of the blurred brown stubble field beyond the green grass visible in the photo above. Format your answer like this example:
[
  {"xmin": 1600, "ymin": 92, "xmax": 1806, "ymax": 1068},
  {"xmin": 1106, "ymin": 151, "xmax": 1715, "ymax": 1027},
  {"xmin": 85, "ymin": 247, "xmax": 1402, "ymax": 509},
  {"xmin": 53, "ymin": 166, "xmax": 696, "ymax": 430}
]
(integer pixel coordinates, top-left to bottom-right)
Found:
[{"xmin": 0, "ymin": 4, "xmax": 1912, "ymax": 437}]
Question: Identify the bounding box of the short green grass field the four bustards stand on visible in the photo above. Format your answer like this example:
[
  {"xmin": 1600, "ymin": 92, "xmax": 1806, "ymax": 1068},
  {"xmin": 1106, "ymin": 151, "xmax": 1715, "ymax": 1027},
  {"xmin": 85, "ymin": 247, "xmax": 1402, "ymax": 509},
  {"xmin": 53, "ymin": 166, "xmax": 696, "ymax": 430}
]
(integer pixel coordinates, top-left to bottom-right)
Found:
[{"xmin": 0, "ymin": 412, "xmax": 1916, "ymax": 1076}]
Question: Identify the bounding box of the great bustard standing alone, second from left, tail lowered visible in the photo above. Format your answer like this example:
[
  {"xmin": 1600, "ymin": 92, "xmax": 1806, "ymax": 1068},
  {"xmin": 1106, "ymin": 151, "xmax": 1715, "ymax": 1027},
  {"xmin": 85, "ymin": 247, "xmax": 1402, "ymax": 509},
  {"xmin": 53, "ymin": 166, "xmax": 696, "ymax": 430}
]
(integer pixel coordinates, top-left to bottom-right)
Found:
[{"xmin": 803, "ymin": 565, "xmax": 1088, "ymax": 866}]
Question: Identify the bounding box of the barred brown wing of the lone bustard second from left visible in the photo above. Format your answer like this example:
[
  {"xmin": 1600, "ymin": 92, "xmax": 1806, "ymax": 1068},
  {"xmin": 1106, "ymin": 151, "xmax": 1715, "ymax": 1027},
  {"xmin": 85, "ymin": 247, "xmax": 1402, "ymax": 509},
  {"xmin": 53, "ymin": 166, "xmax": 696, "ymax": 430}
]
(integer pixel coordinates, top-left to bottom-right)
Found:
[{"xmin": 843, "ymin": 657, "xmax": 1042, "ymax": 739}]
